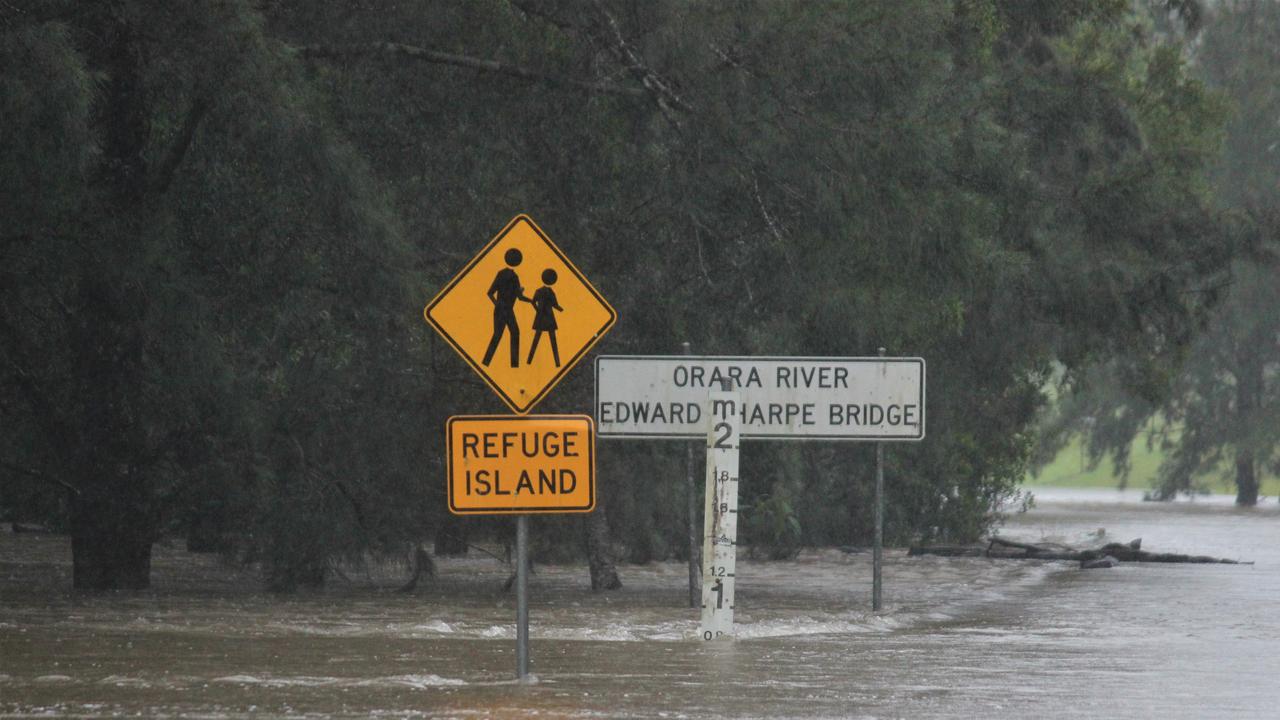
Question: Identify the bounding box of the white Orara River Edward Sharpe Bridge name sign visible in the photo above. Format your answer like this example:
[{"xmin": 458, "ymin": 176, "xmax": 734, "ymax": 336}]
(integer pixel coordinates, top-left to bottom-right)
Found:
[{"xmin": 595, "ymin": 355, "xmax": 924, "ymax": 441}]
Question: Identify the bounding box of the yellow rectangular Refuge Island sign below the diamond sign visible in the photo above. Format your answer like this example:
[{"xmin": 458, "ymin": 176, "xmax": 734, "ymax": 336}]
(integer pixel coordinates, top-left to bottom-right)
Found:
[{"xmin": 445, "ymin": 415, "xmax": 595, "ymax": 515}]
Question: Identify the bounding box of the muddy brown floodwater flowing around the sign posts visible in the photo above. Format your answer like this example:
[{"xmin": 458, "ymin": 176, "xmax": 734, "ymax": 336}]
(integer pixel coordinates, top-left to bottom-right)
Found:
[{"xmin": 0, "ymin": 491, "xmax": 1280, "ymax": 719}]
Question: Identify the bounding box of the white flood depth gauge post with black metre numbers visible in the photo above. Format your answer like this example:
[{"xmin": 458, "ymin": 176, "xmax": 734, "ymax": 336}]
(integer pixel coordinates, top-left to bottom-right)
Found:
[{"xmin": 699, "ymin": 383, "xmax": 742, "ymax": 641}]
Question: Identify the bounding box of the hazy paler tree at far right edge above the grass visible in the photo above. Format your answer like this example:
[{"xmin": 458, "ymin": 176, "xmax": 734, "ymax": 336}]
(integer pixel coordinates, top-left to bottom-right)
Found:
[{"xmin": 1160, "ymin": 3, "xmax": 1280, "ymax": 506}]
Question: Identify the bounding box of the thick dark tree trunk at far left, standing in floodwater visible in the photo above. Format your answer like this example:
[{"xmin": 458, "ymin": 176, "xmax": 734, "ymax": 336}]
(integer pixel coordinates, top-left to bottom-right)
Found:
[{"xmin": 70, "ymin": 13, "xmax": 159, "ymax": 591}]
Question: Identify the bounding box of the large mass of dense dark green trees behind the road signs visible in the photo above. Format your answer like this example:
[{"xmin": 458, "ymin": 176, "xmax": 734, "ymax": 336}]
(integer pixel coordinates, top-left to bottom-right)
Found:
[{"xmin": 0, "ymin": 0, "xmax": 1235, "ymax": 588}]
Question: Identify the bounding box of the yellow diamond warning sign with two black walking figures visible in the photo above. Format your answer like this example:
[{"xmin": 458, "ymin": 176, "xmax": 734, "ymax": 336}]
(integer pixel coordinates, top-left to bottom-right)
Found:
[{"xmin": 424, "ymin": 215, "xmax": 617, "ymax": 415}]
